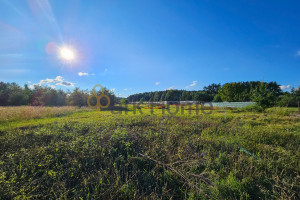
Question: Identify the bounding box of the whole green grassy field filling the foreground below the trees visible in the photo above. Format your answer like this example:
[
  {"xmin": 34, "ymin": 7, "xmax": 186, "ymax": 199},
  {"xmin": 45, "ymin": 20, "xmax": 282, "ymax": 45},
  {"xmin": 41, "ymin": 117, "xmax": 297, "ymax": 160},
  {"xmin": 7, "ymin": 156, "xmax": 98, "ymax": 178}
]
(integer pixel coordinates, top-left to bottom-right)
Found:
[{"xmin": 0, "ymin": 106, "xmax": 300, "ymax": 199}]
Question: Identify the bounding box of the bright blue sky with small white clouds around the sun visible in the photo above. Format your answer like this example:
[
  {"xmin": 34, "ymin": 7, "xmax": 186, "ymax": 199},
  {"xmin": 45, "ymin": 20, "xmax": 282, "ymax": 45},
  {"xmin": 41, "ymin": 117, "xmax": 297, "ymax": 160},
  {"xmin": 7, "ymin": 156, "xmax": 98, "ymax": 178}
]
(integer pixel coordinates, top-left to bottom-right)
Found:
[{"xmin": 0, "ymin": 0, "xmax": 300, "ymax": 97}]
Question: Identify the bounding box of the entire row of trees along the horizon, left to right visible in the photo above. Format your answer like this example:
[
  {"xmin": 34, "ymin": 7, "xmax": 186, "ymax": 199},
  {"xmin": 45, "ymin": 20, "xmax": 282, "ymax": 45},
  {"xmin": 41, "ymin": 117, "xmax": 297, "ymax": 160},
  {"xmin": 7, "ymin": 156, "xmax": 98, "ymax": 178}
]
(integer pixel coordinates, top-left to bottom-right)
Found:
[{"xmin": 0, "ymin": 81, "xmax": 300, "ymax": 107}]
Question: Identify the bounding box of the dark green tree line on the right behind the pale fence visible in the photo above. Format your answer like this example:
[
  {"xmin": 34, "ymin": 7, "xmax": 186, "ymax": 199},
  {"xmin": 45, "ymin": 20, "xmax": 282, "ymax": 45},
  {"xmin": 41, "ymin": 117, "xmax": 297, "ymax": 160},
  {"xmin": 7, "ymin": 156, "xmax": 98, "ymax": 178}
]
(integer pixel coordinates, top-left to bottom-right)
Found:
[{"xmin": 127, "ymin": 81, "xmax": 300, "ymax": 107}]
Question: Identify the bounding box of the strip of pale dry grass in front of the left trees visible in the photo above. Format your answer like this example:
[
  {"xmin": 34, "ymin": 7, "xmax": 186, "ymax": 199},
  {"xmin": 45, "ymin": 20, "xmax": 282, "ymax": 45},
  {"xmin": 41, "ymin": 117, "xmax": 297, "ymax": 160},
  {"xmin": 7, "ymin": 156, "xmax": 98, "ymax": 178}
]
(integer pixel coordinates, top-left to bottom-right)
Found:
[{"xmin": 0, "ymin": 106, "xmax": 89, "ymax": 122}]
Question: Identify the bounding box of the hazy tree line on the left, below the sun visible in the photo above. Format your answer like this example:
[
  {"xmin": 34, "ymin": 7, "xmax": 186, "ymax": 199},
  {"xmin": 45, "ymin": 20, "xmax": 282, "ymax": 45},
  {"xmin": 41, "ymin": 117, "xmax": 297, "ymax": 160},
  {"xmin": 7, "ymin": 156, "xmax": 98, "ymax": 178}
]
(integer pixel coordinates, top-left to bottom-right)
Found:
[{"xmin": 0, "ymin": 82, "xmax": 117, "ymax": 107}]
